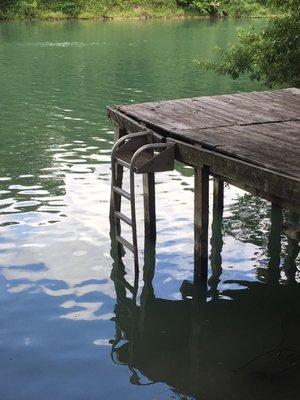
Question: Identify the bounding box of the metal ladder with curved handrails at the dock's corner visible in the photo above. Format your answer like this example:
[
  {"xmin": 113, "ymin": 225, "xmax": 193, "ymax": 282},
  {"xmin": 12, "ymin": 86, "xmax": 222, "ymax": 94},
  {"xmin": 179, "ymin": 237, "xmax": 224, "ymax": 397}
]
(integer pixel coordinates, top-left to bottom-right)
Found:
[{"xmin": 111, "ymin": 130, "xmax": 175, "ymax": 276}]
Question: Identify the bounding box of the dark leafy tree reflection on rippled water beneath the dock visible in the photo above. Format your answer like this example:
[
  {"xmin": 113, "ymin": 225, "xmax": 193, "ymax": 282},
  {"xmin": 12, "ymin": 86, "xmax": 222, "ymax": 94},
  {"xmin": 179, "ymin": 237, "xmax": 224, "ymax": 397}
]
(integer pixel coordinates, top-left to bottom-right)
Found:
[{"xmin": 223, "ymin": 193, "xmax": 300, "ymax": 281}]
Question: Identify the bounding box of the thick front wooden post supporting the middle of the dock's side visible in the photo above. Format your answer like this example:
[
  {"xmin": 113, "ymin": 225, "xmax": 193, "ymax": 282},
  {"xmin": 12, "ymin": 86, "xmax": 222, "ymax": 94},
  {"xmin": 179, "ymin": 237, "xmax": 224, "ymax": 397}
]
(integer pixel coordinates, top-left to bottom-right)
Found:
[{"xmin": 194, "ymin": 165, "xmax": 209, "ymax": 296}]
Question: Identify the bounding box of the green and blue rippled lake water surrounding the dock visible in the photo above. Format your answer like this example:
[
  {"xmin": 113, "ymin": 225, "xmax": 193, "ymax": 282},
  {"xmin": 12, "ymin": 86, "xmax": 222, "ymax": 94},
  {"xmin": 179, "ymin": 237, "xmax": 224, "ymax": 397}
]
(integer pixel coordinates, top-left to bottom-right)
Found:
[{"xmin": 0, "ymin": 20, "xmax": 300, "ymax": 400}]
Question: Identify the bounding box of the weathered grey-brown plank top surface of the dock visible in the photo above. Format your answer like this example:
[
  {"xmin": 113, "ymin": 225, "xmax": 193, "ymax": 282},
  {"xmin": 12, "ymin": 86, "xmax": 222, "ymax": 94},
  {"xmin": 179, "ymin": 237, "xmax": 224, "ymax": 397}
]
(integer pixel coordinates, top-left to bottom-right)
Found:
[{"xmin": 118, "ymin": 88, "xmax": 300, "ymax": 180}]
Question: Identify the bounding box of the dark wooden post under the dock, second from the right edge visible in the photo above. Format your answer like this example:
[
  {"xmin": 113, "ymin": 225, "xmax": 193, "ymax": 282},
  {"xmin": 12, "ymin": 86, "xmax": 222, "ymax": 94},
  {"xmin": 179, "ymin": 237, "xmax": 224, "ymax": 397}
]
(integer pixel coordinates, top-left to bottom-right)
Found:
[{"xmin": 268, "ymin": 203, "xmax": 283, "ymax": 285}]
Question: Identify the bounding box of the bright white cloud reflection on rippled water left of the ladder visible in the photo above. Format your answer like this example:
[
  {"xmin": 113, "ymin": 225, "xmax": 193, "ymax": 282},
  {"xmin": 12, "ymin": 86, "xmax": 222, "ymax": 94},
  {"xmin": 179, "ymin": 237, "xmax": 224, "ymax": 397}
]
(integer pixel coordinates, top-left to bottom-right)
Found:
[{"xmin": 1, "ymin": 155, "xmax": 115, "ymax": 320}]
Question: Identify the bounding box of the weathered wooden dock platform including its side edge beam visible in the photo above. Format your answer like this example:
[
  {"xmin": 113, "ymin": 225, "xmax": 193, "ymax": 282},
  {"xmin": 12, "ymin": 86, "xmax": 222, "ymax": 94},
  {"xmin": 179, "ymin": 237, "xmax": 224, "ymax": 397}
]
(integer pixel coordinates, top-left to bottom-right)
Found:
[{"xmin": 109, "ymin": 88, "xmax": 300, "ymax": 208}]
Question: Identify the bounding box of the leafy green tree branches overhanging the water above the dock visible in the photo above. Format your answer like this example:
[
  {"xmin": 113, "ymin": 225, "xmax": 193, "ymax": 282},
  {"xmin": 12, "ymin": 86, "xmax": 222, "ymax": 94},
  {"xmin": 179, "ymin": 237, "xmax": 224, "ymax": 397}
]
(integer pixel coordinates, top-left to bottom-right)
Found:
[{"xmin": 196, "ymin": 0, "xmax": 300, "ymax": 87}]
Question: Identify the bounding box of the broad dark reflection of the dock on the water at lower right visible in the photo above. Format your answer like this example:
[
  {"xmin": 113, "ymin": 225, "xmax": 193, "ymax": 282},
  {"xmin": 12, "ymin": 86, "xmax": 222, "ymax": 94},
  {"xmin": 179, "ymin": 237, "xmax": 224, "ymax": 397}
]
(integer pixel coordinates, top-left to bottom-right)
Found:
[{"xmin": 113, "ymin": 288, "xmax": 300, "ymax": 399}]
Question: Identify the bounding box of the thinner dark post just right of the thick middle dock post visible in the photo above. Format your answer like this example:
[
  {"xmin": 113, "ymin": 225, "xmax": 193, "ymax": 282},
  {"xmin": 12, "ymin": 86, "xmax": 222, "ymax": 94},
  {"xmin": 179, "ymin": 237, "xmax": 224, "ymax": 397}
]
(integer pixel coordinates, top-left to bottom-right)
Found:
[{"xmin": 208, "ymin": 177, "xmax": 224, "ymax": 298}]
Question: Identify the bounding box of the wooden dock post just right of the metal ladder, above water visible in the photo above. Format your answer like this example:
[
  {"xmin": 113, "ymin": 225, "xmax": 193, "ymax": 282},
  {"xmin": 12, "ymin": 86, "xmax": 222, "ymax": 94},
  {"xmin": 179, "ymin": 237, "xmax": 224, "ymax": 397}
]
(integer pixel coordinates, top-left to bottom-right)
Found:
[{"xmin": 143, "ymin": 172, "xmax": 156, "ymax": 242}]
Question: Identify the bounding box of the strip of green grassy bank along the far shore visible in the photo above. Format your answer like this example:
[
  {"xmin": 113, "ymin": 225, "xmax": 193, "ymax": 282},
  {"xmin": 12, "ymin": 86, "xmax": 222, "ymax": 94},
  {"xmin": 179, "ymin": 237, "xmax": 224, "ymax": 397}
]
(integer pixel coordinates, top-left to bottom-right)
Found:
[{"xmin": 0, "ymin": 0, "xmax": 276, "ymax": 18}]
